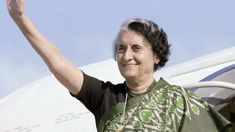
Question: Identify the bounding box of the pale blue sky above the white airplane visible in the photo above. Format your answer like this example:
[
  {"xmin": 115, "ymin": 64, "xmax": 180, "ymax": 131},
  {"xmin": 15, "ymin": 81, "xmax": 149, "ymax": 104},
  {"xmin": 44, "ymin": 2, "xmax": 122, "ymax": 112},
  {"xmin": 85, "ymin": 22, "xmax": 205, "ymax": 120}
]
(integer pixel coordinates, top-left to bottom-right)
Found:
[{"xmin": 0, "ymin": 0, "xmax": 235, "ymax": 98}]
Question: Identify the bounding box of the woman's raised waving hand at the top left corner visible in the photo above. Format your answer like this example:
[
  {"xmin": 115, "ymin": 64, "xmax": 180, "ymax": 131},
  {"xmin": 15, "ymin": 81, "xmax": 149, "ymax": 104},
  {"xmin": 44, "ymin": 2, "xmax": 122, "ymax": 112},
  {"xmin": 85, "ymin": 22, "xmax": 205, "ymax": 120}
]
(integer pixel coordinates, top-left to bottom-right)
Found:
[{"xmin": 7, "ymin": 0, "xmax": 24, "ymax": 19}]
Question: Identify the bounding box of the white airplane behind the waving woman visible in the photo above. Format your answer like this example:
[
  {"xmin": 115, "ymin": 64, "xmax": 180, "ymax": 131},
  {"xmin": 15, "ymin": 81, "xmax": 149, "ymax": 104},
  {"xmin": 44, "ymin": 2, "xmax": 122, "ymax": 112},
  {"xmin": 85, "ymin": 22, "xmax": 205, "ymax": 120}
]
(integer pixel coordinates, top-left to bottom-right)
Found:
[{"xmin": 0, "ymin": 47, "xmax": 235, "ymax": 132}]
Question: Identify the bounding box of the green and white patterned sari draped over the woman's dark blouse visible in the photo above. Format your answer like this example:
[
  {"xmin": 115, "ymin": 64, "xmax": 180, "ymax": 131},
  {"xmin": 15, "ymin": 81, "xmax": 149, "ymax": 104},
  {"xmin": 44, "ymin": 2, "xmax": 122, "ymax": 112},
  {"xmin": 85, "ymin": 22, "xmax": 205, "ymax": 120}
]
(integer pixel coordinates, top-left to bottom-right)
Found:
[{"xmin": 98, "ymin": 79, "xmax": 231, "ymax": 132}]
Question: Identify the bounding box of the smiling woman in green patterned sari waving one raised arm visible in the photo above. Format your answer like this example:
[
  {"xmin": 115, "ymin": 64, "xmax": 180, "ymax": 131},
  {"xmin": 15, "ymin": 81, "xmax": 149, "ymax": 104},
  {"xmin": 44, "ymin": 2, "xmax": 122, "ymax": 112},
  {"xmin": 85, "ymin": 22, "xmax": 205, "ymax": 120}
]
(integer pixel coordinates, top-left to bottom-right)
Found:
[{"xmin": 7, "ymin": 0, "xmax": 231, "ymax": 132}]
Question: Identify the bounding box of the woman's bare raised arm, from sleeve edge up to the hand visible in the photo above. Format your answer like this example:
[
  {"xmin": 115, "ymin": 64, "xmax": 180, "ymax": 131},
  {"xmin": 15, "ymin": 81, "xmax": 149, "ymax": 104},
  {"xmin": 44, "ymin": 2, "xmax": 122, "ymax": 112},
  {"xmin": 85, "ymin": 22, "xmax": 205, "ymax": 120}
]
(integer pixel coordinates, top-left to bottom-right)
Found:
[{"xmin": 7, "ymin": 0, "xmax": 83, "ymax": 94}]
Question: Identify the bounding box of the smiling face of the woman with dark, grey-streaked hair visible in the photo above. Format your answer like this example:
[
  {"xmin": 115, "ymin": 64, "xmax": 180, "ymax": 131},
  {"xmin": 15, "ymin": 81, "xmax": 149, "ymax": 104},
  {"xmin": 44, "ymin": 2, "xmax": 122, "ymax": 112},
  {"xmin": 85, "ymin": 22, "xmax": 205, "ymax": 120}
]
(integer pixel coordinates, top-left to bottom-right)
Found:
[{"xmin": 116, "ymin": 30, "xmax": 159, "ymax": 80}]
